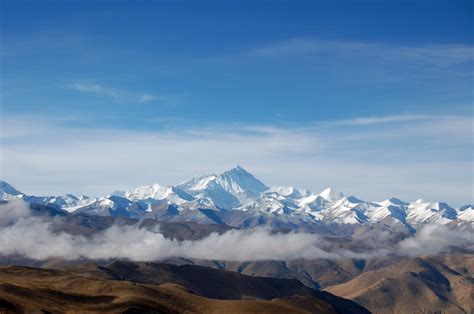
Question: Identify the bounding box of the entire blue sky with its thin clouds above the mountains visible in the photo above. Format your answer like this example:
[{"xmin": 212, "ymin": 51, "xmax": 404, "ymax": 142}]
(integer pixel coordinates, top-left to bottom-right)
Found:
[{"xmin": 0, "ymin": 0, "xmax": 474, "ymax": 203}]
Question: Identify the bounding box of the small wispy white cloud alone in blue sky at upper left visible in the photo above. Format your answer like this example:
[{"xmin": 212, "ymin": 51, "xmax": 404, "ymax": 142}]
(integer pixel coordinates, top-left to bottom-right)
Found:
[{"xmin": 66, "ymin": 83, "xmax": 161, "ymax": 103}]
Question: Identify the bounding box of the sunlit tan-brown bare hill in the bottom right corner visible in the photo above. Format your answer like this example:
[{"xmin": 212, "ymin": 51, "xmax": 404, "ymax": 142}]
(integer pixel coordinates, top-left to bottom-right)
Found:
[{"xmin": 326, "ymin": 254, "xmax": 474, "ymax": 313}]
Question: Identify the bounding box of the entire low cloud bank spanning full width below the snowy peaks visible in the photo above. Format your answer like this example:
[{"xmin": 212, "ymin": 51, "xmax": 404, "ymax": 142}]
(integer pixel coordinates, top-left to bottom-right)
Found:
[{"xmin": 0, "ymin": 200, "xmax": 473, "ymax": 261}]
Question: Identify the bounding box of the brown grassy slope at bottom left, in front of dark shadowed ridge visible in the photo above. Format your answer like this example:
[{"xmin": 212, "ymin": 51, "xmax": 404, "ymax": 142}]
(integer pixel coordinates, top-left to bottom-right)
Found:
[{"xmin": 0, "ymin": 266, "xmax": 337, "ymax": 313}]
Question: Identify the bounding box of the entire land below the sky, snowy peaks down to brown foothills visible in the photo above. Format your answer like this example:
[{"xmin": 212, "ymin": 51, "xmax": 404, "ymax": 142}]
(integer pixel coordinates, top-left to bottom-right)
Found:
[{"xmin": 0, "ymin": 166, "xmax": 474, "ymax": 313}]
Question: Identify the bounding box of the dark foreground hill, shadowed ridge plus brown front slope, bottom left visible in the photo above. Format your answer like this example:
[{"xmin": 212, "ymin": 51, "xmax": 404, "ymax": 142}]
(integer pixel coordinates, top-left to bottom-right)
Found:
[{"xmin": 0, "ymin": 263, "xmax": 368, "ymax": 313}]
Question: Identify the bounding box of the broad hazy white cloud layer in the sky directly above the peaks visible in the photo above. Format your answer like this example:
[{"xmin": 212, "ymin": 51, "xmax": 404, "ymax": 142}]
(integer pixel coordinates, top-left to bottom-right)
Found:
[{"xmin": 1, "ymin": 116, "xmax": 473, "ymax": 206}]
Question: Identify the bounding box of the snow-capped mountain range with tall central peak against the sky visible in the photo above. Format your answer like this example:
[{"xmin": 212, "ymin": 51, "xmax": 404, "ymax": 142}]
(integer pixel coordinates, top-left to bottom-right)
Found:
[{"xmin": 0, "ymin": 166, "xmax": 474, "ymax": 231}]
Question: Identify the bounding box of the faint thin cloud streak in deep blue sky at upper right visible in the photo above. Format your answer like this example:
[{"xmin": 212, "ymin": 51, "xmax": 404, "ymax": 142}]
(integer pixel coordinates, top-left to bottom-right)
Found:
[{"xmin": 254, "ymin": 38, "xmax": 474, "ymax": 67}]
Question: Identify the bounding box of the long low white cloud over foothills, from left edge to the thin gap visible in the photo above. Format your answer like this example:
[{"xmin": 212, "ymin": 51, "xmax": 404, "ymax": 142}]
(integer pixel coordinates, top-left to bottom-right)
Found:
[{"xmin": 0, "ymin": 203, "xmax": 337, "ymax": 261}]
